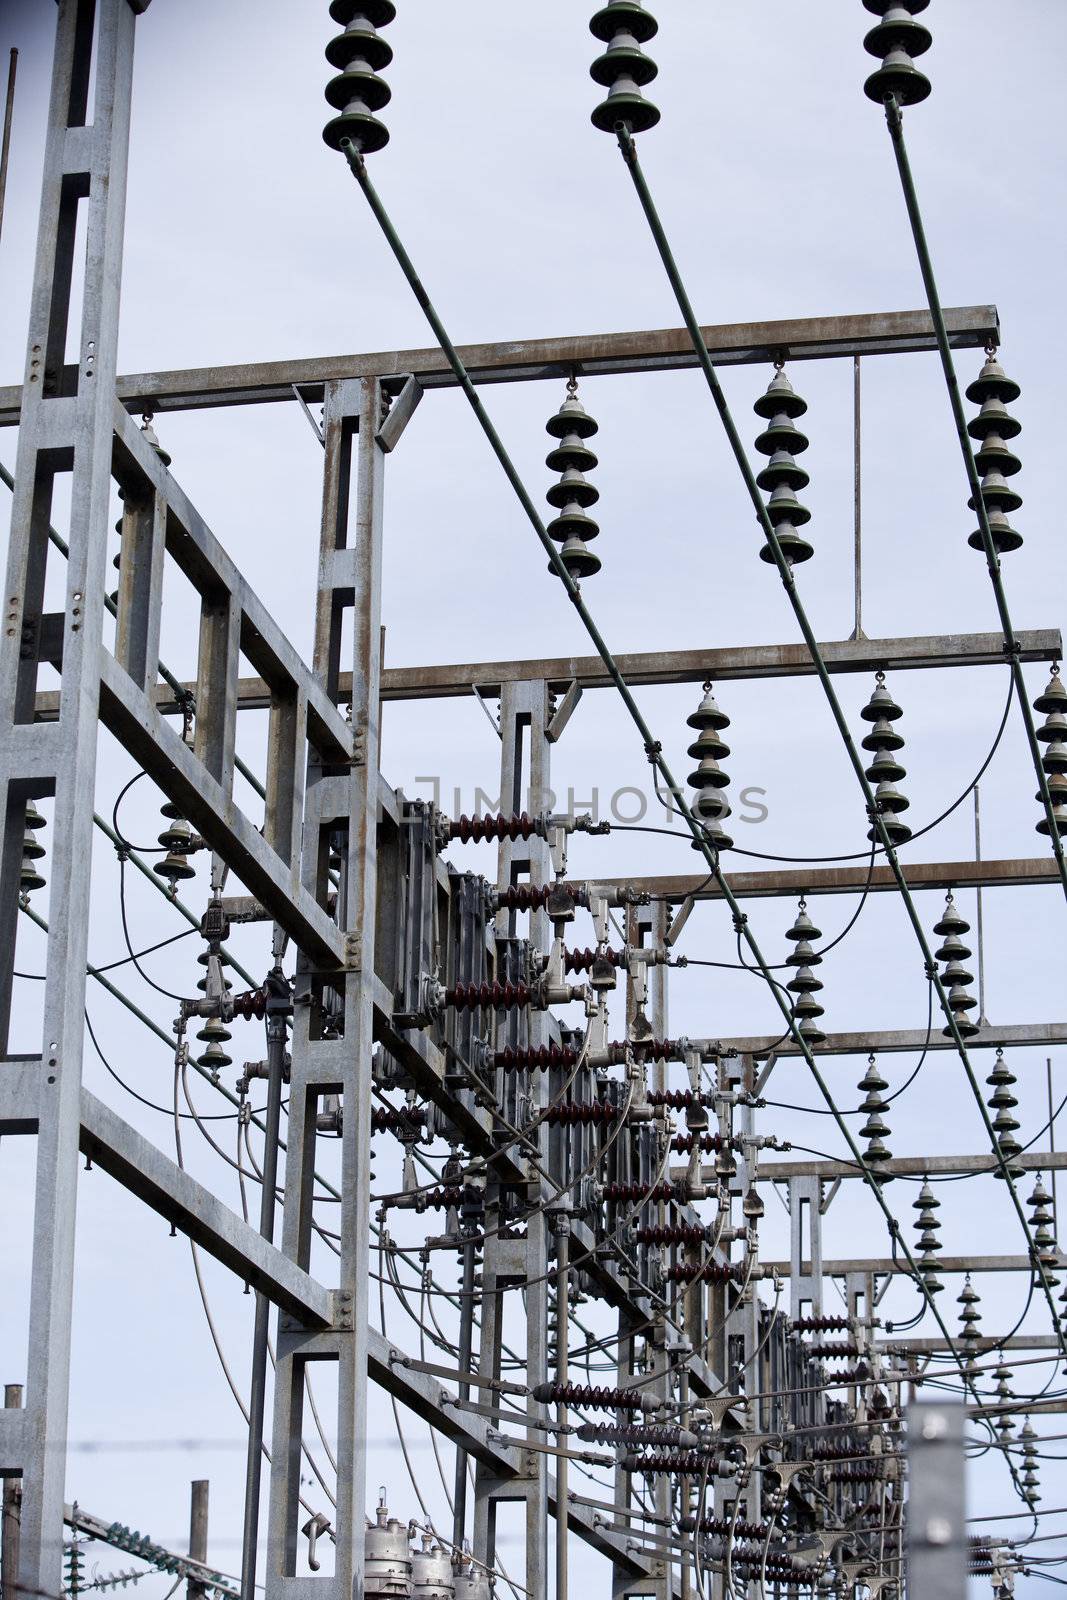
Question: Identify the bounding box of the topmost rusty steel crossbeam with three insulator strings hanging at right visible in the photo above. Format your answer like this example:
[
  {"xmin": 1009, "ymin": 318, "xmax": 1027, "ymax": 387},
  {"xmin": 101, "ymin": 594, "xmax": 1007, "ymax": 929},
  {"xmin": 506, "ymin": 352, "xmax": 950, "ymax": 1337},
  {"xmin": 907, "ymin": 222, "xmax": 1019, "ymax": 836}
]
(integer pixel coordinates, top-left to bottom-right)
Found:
[{"xmin": 0, "ymin": 306, "xmax": 1000, "ymax": 427}]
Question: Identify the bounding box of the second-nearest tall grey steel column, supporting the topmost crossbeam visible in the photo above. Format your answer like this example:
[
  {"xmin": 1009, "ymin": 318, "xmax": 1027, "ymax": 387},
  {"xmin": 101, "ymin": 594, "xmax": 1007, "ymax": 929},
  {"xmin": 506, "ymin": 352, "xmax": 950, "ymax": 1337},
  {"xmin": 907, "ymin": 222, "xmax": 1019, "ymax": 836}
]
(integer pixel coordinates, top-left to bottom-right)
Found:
[{"xmin": 266, "ymin": 378, "xmax": 384, "ymax": 1600}]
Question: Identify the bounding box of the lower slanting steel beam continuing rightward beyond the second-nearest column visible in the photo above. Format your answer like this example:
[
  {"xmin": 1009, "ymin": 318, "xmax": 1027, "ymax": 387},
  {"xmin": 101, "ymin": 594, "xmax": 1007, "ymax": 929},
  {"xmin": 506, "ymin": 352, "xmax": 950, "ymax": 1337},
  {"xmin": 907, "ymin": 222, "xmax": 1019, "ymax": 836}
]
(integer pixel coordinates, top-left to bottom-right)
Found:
[{"xmin": 368, "ymin": 1328, "xmax": 649, "ymax": 1574}]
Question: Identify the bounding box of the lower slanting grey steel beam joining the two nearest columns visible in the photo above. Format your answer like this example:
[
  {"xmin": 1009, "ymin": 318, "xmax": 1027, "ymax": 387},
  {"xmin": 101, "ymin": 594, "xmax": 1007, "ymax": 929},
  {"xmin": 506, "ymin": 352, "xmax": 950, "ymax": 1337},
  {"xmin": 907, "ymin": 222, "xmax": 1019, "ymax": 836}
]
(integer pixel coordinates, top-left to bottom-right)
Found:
[{"xmin": 79, "ymin": 1090, "xmax": 333, "ymax": 1328}]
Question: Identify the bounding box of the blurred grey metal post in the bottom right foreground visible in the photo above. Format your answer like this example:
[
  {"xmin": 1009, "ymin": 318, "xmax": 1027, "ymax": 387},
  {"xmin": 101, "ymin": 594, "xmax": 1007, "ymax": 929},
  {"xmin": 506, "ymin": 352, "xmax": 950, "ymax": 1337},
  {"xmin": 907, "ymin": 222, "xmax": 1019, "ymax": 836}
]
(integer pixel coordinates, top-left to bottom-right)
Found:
[{"xmin": 907, "ymin": 1402, "xmax": 968, "ymax": 1600}]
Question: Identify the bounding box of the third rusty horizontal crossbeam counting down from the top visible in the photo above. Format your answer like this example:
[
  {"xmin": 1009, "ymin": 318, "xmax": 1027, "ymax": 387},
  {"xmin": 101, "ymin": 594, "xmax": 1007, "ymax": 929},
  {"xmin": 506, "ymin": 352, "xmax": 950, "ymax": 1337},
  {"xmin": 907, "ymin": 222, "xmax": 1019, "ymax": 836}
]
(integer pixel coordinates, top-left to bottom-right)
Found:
[{"xmin": 620, "ymin": 857, "xmax": 1059, "ymax": 904}]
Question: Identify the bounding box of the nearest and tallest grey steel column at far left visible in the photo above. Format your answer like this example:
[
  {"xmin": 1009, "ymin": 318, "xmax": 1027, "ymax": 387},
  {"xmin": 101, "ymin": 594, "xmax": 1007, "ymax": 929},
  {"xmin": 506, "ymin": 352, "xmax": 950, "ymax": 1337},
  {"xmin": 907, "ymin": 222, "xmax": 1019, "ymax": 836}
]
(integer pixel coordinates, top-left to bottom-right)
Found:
[{"xmin": 0, "ymin": 12, "xmax": 137, "ymax": 1594}]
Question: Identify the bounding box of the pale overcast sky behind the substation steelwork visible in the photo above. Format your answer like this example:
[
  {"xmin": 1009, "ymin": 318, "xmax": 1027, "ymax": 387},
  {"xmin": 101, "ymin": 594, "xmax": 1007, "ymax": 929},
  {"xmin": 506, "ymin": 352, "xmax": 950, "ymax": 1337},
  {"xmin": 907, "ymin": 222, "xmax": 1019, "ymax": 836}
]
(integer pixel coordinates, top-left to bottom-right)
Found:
[{"xmin": 0, "ymin": 0, "xmax": 1067, "ymax": 1595}]
